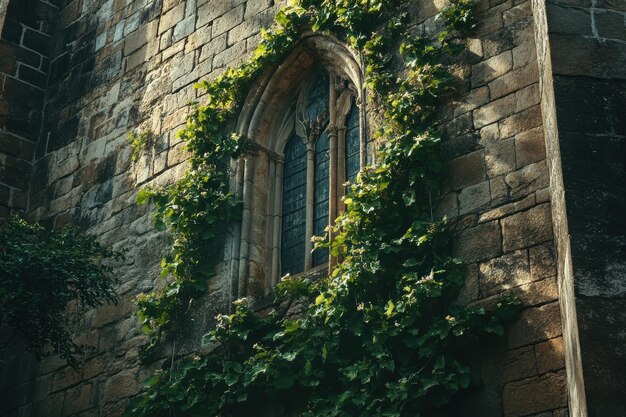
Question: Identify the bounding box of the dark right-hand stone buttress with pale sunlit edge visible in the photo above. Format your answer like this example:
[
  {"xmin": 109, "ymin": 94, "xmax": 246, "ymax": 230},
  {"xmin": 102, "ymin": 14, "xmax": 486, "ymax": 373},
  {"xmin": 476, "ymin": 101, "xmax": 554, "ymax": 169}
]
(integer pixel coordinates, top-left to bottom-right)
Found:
[{"xmin": 538, "ymin": 0, "xmax": 626, "ymax": 416}]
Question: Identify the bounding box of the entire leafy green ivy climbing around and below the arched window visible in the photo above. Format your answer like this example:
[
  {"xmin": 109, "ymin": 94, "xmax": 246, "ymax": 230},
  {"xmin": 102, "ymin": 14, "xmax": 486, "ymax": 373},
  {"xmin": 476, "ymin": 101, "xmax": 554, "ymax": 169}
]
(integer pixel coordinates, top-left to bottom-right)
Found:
[{"xmin": 127, "ymin": 0, "xmax": 516, "ymax": 417}]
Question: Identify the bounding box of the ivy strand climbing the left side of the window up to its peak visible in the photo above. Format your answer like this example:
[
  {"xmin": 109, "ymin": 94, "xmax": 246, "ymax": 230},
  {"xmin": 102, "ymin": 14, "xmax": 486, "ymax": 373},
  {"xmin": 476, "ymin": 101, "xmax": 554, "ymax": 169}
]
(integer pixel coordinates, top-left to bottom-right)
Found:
[{"xmin": 136, "ymin": 3, "xmax": 304, "ymax": 360}]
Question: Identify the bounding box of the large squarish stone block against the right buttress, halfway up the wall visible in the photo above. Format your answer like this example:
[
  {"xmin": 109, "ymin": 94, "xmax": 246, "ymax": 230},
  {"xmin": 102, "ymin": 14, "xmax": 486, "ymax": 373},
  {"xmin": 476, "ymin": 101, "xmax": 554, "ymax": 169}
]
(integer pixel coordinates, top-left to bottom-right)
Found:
[{"xmin": 502, "ymin": 204, "xmax": 553, "ymax": 252}]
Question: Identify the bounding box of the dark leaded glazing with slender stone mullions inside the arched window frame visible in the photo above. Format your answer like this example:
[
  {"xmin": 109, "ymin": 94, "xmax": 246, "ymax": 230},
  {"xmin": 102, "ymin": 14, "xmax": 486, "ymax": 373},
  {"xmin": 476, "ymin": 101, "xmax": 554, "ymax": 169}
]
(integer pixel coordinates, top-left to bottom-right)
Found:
[{"xmin": 280, "ymin": 68, "xmax": 360, "ymax": 275}]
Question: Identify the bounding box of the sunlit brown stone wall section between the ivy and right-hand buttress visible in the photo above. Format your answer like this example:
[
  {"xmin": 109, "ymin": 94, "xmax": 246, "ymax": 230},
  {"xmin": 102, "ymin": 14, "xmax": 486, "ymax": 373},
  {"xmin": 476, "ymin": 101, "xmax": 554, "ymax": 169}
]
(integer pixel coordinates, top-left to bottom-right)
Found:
[{"xmin": 440, "ymin": 1, "xmax": 568, "ymax": 417}]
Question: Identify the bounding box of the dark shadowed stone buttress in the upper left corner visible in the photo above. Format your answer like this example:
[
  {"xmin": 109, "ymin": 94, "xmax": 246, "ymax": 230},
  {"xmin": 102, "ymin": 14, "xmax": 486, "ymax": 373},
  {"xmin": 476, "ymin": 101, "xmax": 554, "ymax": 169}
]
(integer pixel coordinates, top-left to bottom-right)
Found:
[{"xmin": 0, "ymin": 0, "xmax": 57, "ymax": 217}]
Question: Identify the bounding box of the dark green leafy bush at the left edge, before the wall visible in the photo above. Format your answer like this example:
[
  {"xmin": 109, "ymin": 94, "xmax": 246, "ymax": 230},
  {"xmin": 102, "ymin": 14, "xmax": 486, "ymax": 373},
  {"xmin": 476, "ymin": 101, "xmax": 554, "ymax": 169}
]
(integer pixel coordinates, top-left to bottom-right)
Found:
[{"xmin": 0, "ymin": 216, "xmax": 121, "ymax": 368}]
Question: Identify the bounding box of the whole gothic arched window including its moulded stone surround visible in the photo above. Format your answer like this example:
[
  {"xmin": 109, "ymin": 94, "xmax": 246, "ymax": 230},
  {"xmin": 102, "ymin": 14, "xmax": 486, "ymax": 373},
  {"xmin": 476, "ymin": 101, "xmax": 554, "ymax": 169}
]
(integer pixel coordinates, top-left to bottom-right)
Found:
[{"xmin": 232, "ymin": 34, "xmax": 367, "ymax": 303}]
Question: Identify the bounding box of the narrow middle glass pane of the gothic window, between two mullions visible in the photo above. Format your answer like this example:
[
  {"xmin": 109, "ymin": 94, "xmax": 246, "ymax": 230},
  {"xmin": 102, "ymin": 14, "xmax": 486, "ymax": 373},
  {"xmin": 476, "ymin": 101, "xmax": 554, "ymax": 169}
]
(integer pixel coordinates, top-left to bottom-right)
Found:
[{"xmin": 313, "ymin": 132, "xmax": 329, "ymax": 266}]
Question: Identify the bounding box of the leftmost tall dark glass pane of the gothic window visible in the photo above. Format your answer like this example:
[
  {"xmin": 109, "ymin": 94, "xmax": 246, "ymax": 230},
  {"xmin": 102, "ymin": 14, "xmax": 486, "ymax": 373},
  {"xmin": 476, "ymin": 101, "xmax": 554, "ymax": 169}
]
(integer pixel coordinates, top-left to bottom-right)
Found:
[{"xmin": 280, "ymin": 134, "xmax": 306, "ymax": 275}]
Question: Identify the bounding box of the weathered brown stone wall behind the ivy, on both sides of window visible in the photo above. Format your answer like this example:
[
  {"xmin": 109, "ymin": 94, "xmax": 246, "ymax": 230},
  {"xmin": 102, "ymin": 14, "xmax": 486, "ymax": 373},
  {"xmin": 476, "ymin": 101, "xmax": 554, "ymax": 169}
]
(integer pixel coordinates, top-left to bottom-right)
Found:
[{"xmin": 0, "ymin": 0, "xmax": 584, "ymax": 417}]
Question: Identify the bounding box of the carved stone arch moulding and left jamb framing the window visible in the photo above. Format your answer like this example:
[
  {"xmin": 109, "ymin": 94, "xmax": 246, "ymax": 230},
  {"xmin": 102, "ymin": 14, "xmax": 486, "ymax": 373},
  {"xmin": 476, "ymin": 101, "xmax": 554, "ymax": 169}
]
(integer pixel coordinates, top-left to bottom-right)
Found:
[{"xmin": 227, "ymin": 32, "xmax": 367, "ymax": 305}]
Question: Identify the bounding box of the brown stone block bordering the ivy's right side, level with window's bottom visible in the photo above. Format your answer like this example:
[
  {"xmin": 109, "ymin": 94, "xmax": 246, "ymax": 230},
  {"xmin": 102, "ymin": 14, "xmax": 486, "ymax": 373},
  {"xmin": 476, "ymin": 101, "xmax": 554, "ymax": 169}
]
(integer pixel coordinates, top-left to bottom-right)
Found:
[{"xmin": 453, "ymin": 221, "xmax": 502, "ymax": 262}]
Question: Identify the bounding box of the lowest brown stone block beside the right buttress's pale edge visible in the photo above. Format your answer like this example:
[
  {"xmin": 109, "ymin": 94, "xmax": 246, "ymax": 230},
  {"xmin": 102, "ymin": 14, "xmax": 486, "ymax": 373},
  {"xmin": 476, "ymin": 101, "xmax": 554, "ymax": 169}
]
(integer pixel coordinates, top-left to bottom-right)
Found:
[{"xmin": 503, "ymin": 371, "xmax": 567, "ymax": 417}]
